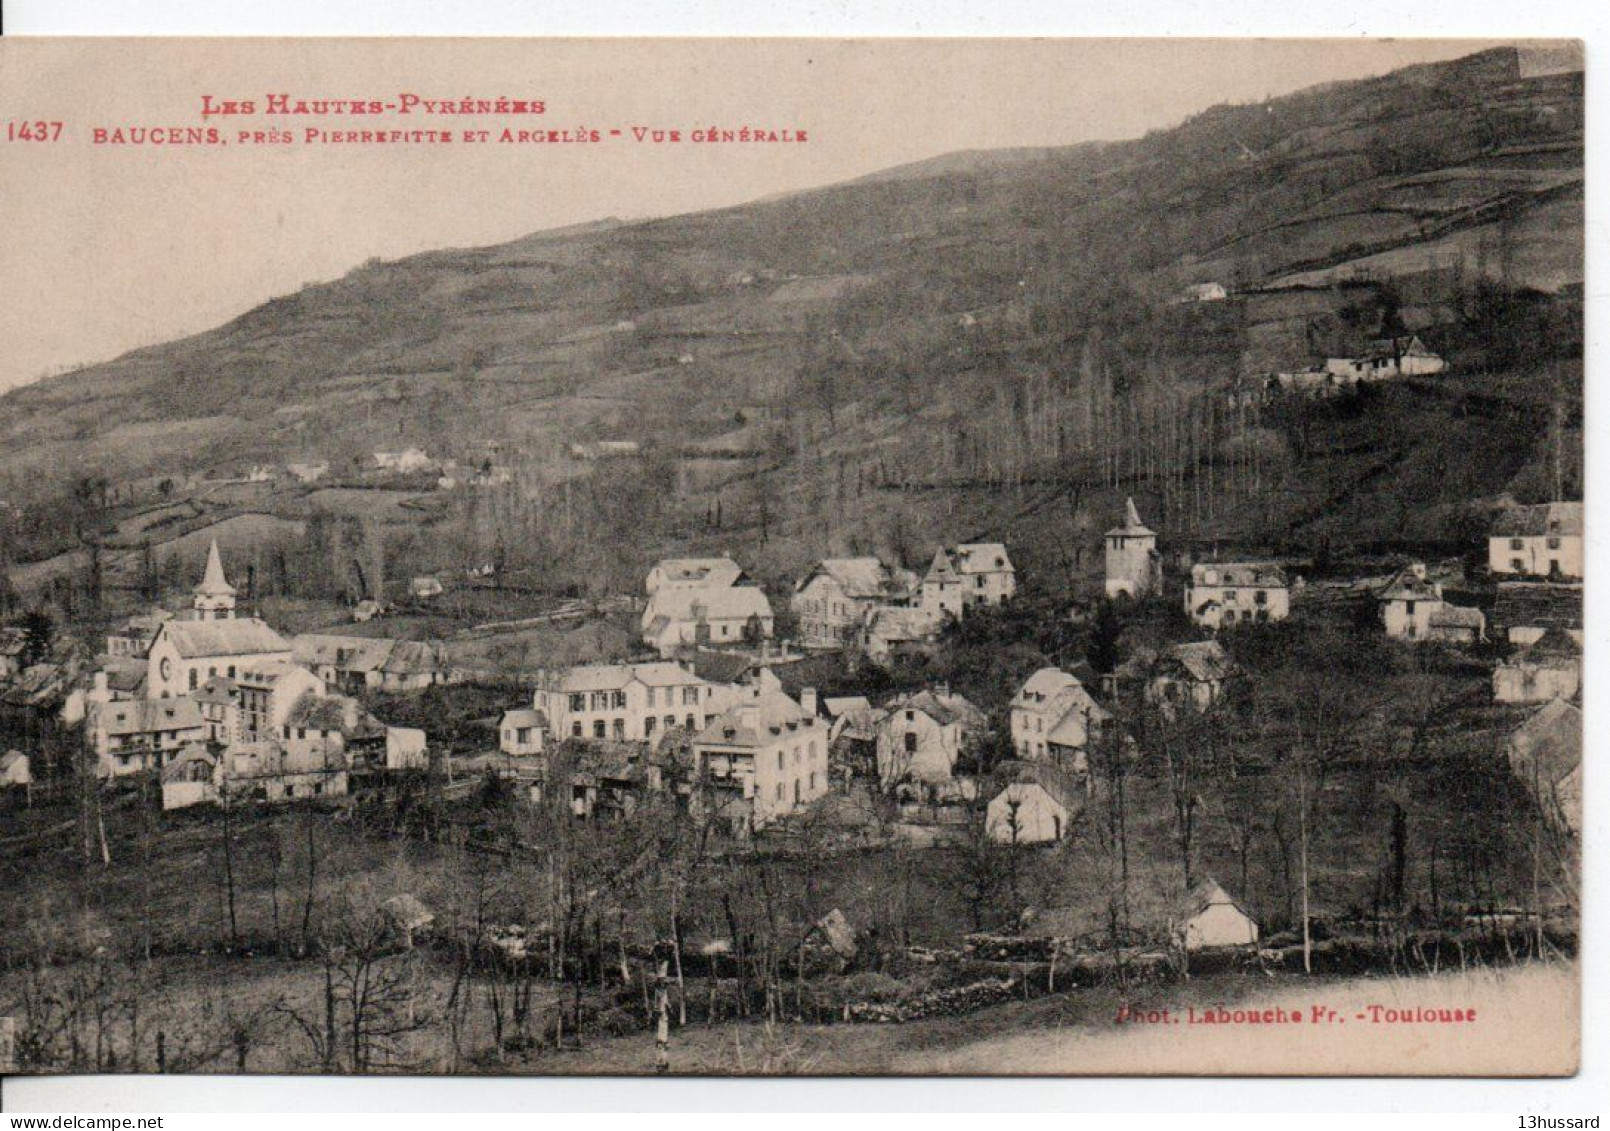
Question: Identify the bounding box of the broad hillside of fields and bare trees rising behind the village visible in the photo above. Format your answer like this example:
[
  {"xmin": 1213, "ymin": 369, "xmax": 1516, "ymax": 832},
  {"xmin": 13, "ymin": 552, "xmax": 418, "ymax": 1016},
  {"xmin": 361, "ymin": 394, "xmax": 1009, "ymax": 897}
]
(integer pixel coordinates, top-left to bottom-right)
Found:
[{"xmin": 0, "ymin": 50, "xmax": 1583, "ymax": 602}]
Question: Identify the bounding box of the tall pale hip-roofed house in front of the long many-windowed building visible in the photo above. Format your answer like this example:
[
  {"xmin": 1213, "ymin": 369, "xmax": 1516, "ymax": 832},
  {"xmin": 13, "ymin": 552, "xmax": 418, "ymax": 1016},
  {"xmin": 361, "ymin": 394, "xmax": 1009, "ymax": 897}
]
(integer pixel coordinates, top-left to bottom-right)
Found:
[{"xmin": 692, "ymin": 685, "xmax": 828, "ymax": 828}]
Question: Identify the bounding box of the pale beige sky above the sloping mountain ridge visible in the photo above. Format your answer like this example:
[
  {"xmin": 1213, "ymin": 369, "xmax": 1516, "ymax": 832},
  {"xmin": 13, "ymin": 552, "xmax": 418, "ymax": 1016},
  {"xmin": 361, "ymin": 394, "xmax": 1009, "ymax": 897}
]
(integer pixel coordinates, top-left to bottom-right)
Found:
[{"xmin": 0, "ymin": 39, "xmax": 1513, "ymax": 392}]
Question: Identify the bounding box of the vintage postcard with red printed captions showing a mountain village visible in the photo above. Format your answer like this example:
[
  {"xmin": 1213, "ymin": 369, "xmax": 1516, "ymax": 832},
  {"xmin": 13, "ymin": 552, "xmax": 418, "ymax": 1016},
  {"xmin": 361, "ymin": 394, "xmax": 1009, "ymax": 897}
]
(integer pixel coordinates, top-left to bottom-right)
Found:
[{"xmin": 0, "ymin": 39, "xmax": 1584, "ymax": 1076}]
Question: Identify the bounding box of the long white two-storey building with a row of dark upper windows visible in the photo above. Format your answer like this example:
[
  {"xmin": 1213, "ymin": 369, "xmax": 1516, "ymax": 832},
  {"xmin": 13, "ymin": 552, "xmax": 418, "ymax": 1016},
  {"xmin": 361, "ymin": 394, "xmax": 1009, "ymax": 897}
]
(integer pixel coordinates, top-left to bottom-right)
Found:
[{"xmin": 531, "ymin": 662, "xmax": 739, "ymax": 741}]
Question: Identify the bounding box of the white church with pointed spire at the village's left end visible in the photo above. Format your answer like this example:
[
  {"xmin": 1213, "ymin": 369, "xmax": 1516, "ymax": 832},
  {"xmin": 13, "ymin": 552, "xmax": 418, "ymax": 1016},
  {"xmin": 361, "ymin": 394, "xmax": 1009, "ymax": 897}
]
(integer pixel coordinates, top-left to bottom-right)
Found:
[{"xmin": 145, "ymin": 541, "xmax": 291, "ymax": 699}]
